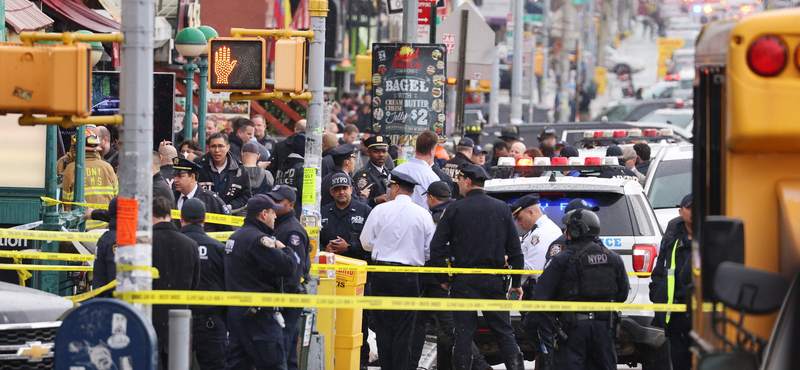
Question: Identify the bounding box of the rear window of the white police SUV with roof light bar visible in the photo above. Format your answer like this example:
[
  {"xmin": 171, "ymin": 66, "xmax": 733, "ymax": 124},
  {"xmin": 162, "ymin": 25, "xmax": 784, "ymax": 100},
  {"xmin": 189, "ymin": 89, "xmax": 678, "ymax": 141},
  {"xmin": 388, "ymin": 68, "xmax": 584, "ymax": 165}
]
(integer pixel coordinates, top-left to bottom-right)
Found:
[{"xmin": 489, "ymin": 192, "xmax": 639, "ymax": 236}]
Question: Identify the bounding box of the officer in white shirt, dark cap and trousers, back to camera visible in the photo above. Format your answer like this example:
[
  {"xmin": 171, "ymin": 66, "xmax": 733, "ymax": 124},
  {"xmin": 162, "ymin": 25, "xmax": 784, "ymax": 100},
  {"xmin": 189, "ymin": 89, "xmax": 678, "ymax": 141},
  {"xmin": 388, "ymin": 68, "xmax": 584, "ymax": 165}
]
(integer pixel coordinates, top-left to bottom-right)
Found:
[{"xmin": 361, "ymin": 173, "xmax": 434, "ymax": 370}]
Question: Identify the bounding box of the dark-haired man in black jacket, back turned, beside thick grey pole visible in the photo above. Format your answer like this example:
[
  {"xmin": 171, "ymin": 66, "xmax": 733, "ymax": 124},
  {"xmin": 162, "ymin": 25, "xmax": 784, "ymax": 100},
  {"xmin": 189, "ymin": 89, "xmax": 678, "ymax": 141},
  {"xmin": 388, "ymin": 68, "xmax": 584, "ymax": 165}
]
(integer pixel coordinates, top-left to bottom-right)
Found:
[{"xmin": 153, "ymin": 197, "xmax": 200, "ymax": 369}]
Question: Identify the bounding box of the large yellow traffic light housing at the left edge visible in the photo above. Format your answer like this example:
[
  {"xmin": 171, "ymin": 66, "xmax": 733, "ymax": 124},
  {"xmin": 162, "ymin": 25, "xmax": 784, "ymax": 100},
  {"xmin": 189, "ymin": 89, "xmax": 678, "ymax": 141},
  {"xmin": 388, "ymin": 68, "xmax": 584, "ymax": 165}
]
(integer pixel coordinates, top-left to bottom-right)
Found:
[{"xmin": 0, "ymin": 43, "xmax": 92, "ymax": 118}]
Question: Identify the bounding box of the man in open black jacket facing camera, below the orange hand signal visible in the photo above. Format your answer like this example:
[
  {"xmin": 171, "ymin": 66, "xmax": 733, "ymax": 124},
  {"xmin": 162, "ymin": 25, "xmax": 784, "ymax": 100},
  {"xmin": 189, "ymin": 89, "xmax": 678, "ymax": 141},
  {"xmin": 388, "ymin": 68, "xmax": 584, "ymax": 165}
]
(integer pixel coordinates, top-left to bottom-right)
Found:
[{"xmin": 195, "ymin": 133, "xmax": 252, "ymax": 214}]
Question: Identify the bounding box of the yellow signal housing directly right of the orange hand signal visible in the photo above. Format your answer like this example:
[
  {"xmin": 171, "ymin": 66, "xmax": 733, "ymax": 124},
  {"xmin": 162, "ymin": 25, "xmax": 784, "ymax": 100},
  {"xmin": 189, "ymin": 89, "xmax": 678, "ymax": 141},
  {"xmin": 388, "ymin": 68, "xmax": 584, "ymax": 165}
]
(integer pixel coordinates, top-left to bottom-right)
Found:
[{"xmin": 275, "ymin": 37, "xmax": 306, "ymax": 94}]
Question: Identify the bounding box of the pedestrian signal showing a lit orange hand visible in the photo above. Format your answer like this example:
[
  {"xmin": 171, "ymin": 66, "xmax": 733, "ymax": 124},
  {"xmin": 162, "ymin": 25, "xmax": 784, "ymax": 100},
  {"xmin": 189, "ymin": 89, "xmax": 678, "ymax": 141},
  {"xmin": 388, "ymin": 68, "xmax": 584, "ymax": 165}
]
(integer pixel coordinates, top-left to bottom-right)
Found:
[{"xmin": 208, "ymin": 37, "xmax": 267, "ymax": 92}]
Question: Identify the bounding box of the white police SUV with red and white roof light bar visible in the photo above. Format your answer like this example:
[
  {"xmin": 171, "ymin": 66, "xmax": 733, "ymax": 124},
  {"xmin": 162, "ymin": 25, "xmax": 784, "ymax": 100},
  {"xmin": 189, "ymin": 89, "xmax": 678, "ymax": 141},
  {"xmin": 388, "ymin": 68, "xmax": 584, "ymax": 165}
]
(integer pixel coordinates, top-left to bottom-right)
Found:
[{"xmin": 475, "ymin": 152, "xmax": 670, "ymax": 370}]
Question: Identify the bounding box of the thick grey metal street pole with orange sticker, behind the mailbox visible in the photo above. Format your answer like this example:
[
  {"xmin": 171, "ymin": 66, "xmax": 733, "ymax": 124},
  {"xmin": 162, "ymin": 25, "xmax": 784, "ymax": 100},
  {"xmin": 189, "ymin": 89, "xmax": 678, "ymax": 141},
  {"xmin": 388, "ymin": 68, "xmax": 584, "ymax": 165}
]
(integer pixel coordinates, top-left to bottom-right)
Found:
[{"xmin": 116, "ymin": 0, "xmax": 155, "ymax": 318}]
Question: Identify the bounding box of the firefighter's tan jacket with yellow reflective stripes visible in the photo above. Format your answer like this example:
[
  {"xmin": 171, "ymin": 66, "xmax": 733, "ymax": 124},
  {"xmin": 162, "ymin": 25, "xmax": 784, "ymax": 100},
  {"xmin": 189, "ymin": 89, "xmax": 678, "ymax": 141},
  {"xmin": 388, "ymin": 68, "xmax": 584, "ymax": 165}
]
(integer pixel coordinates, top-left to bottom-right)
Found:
[{"xmin": 61, "ymin": 151, "xmax": 119, "ymax": 229}]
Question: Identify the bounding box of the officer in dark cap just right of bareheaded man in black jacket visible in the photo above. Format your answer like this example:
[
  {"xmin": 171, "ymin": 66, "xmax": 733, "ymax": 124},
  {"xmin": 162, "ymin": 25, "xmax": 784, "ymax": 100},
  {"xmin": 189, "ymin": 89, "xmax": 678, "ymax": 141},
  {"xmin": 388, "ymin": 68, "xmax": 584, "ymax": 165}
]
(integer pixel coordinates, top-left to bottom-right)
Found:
[{"xmin": 181, "ymin": 198, "xmax": 228, "ymax": 370}]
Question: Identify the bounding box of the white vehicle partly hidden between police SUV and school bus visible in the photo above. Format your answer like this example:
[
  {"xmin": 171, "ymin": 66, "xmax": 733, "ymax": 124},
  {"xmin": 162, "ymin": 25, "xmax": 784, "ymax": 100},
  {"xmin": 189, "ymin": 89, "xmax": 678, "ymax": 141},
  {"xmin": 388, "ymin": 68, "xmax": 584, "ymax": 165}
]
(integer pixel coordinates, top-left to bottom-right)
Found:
[{"xmin": 644, "ymin": 144, "xmax": 694, "ymax": 231}]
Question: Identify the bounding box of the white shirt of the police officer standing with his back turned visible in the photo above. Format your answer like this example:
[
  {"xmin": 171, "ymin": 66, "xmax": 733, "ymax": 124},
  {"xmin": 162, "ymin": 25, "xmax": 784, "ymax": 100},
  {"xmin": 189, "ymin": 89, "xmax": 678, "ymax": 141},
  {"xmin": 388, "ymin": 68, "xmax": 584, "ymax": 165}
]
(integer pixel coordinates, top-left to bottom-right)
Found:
[{"xmin": 361, "ymin": 194, "xmax": 436, "ymax": 266}]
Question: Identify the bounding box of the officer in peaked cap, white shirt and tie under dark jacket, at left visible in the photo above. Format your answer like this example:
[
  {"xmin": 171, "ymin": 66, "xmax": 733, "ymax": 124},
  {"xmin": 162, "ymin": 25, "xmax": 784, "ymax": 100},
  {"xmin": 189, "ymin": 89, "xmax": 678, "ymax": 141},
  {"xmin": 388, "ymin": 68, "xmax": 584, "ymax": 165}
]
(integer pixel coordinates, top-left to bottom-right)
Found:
[{"xmin": 172, "ymin": 157, "xmax": 233, "ymax": 232}]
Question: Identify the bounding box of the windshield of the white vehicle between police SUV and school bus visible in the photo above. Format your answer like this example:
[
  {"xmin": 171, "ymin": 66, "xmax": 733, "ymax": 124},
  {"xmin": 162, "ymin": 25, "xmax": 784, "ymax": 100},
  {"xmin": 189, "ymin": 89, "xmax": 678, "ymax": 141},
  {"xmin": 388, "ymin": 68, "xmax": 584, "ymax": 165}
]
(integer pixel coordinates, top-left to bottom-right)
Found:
[{"xmin": 647, "ymin": 159, "xmax": 692, "ymax": 209}]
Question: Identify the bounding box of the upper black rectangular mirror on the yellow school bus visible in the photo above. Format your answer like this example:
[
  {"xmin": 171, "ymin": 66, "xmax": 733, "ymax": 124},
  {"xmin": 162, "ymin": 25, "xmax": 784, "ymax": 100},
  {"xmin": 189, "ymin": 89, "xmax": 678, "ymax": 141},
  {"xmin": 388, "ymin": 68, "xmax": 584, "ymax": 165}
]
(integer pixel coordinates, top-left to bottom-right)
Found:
[{"xmin": 700, "ymin": 216, "xmax": 744, "ymax": 302}]
